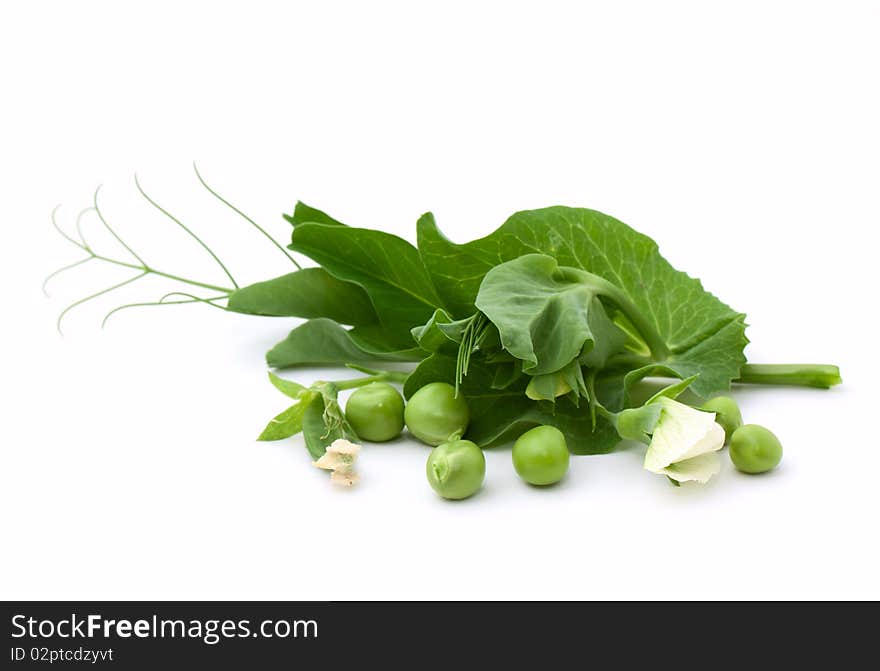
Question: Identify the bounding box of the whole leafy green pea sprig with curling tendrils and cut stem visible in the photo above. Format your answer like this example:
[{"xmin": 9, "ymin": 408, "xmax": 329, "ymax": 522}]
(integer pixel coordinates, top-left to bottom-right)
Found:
[{"xmin": 47, "ymin": 181, "xmax": 840, "ymax": 458}]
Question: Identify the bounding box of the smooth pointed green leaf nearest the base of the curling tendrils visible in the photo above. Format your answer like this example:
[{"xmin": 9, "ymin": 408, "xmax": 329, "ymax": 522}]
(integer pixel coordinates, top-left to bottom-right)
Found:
[{"xmin": 227, "ymin": 268, "xmax": 379, "ymax": 325}]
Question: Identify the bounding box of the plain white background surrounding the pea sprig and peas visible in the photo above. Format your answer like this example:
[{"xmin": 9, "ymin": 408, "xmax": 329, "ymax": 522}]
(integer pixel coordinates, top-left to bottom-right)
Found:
[{"xmin": 0, "ymin": 1, "xmax": 880, "ymax": 599}]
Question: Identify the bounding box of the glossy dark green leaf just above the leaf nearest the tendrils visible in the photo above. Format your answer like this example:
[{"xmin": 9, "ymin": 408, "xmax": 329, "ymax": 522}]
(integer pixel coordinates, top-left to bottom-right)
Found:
[{"xmin": 290, "ymin": 223, "xmax": 443, "ymax": 340}]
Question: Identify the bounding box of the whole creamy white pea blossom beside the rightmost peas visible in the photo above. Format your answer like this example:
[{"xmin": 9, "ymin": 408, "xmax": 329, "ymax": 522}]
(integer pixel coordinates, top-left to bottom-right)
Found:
[{"xmin": 645, "ymin": 398, "xmax": 724, "ymax": 482}]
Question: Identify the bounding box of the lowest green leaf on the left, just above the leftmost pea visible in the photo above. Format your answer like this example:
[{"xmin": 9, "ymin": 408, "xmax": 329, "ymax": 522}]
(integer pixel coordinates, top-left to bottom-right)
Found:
[{"xmin": 266, "ymin": 319, "xmax": 425, "ymax": 368}]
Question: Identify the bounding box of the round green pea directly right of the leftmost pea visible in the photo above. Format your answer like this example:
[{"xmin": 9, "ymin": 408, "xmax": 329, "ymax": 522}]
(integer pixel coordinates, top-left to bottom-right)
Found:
[{"xmin": 404, "ymin": 382, "xmax": 470, "ymax": 445}]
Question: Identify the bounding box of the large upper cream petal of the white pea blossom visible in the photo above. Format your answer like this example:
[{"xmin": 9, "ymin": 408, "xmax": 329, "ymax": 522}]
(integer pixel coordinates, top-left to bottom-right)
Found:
[{"xmin": 645, "ymin": 398, "xmax": 724, "ymax": 473}]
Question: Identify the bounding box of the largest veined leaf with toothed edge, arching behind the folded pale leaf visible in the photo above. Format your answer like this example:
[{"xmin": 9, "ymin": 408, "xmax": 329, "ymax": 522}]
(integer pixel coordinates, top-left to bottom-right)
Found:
[{"xmin": 418, "ymin": 207, "xmax": 747, "ymax": 396}]
